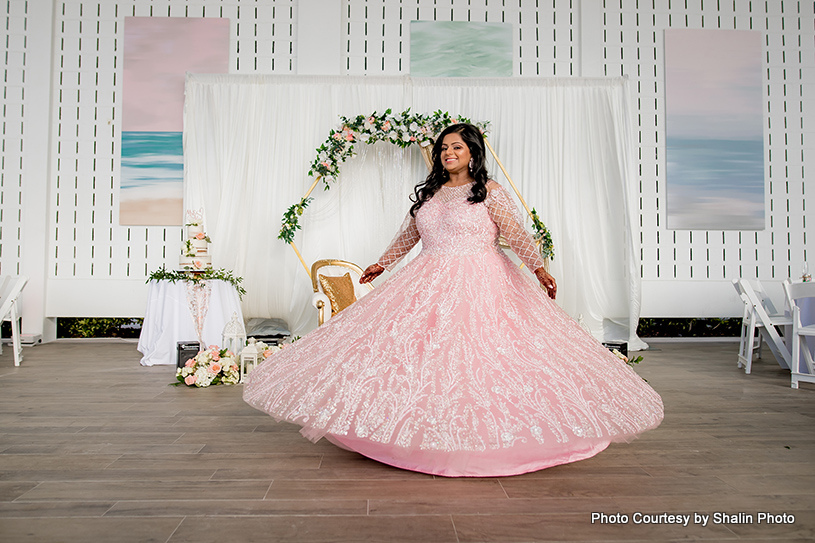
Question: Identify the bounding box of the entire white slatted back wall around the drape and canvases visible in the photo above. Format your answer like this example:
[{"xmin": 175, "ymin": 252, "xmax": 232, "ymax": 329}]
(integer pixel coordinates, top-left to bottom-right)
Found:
[{"xmin": 0, "ymin": 0, "xmax": 815, "ymax": 332}]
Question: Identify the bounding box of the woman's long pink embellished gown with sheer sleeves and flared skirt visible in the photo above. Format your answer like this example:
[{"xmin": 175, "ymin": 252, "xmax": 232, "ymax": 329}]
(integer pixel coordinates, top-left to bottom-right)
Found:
[{"xmin": 243, "ymin": 185, "xmax": 663, "ymax": 476}]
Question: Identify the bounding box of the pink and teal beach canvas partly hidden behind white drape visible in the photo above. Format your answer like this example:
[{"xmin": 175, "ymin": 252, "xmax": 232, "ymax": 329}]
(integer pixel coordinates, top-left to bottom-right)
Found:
[{"xmin": 119, "ymin": 17, "xmax": 229, "ymax": 226}]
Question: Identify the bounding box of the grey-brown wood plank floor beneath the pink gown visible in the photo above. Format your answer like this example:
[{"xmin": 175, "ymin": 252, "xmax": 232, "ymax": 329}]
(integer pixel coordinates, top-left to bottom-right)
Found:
[{"xmin": 0, "ymin": 341, "xmax": 815, "ymax": 543}]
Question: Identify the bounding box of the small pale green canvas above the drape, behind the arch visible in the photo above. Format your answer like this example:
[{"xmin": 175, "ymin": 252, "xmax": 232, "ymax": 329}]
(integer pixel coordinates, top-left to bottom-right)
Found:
[{"xmin": 410, "ymin": 21, "xmax": 512, "ymax": 77}]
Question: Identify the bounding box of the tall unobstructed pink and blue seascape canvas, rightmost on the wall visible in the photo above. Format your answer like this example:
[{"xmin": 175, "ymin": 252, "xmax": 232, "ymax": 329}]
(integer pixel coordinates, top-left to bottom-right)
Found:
[{"xmin": 665, "ymin": 29, "xmax": 765, "ymax": 230}]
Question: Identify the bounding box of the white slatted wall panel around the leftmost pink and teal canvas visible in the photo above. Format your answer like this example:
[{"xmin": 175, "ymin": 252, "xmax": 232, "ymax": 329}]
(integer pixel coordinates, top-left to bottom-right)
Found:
[{"xmin": 32, "ymin": 0, "xmax": 297, "ymax": 316}]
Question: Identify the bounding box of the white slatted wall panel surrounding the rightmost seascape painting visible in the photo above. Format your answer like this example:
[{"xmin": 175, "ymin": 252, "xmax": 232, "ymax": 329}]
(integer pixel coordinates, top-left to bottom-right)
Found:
[{"xmin": 603, "ymin": 0, "xmax": 815, "ymax": 316}]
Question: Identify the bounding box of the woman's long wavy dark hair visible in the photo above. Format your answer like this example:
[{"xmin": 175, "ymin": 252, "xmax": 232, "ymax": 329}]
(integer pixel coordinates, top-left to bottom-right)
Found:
[{"xmin": 410, "ymin": 123, "xmax": 489, "ymax": 217}]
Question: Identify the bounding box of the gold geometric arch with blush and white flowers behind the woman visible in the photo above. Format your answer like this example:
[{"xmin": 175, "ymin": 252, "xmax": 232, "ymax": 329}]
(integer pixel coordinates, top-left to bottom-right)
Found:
[{"xmin": 277, "ymin": 108, "xmax": 554, "ymax": 276}]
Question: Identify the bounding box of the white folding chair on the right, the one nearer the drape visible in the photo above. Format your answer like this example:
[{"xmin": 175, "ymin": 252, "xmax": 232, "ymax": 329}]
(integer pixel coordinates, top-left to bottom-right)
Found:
[{"xmin": 733, "ymin": 279, "xmax": 792, "ymax": 374}]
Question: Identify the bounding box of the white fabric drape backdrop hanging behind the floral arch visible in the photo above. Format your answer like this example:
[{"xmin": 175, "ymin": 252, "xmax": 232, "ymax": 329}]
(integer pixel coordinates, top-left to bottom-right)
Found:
[{"xmin": 184, "ymin": 74, "xmax": 645, "ymax": 349}]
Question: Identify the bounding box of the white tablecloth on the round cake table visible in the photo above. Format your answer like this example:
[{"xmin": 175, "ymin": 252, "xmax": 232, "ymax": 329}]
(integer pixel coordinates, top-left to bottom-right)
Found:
[{"xmin": 138, "ymin": 280, "xmax": 243, "ymax": 366}]
